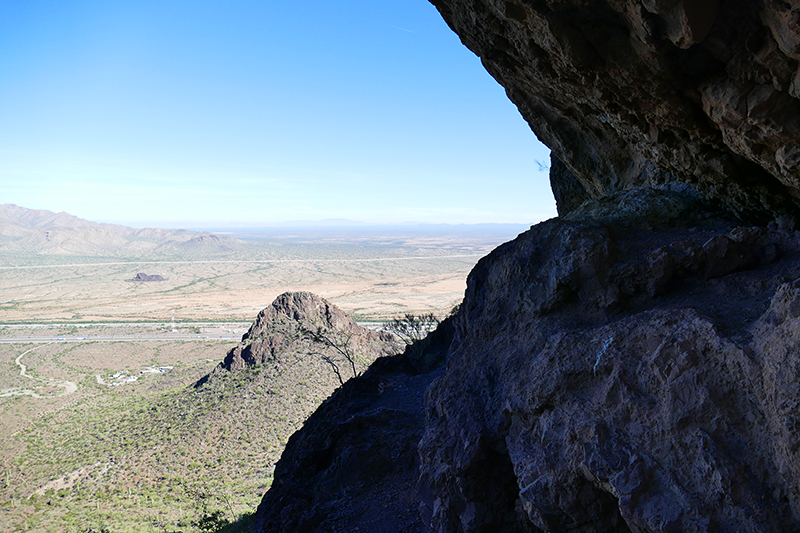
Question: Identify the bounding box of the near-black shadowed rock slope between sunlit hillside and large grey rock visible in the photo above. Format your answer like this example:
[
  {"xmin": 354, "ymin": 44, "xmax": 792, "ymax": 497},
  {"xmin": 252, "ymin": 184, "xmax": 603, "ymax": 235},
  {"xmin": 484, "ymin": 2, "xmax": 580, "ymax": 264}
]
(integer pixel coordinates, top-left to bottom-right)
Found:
[{"xmin": 253, "ymin": 355, "xmax": 434, "ymax": 533}]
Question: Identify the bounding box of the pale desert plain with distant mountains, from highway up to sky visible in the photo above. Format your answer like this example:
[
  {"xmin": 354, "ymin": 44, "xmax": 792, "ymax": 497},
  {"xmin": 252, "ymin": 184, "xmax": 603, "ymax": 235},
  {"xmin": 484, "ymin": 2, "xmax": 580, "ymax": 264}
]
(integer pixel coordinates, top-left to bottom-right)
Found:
[{"xmin": 0, "ymin": 205, "xmax": 526, "ymax": 323}]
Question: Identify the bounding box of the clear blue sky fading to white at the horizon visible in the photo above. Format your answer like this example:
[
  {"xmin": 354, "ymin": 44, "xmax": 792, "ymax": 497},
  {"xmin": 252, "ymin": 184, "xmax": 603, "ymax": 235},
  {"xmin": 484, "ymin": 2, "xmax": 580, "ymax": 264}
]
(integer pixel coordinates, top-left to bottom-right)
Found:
[{"xmin": 0, "ymin": 0, "xmax": 555, "ymax": 227}]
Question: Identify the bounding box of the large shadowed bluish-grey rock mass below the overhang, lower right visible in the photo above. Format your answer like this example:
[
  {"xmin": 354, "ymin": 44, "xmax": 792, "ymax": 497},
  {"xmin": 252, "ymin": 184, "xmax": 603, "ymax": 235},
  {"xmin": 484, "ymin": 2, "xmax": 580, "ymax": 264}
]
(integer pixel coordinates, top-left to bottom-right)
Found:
[{"xmin": 420, "ymin": 190, "xmax": 800, "ymax": 532}]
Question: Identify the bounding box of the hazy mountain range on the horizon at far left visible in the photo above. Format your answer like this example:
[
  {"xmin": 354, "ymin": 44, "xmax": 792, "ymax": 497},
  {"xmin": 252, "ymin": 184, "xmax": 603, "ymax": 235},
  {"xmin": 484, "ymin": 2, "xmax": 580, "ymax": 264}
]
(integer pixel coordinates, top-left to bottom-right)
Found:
[{"xmin": 0, "ymin": 204, "xmax": 241, "ymax": 257}]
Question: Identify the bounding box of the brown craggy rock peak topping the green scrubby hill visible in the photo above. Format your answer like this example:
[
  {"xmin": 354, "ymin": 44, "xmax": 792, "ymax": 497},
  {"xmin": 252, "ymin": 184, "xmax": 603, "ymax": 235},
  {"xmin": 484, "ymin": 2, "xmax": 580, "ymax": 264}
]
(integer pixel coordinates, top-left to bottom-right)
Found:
[{"xmin": 216, "ymin": 292, "xmax": 402, "ymax": 378}]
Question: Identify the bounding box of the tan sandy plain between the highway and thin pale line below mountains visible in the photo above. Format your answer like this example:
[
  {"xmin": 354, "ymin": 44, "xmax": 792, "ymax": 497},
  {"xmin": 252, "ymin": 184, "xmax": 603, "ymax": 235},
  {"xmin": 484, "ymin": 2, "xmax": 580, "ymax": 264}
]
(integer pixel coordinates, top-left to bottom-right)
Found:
[{"xmin": 0, "ymin": 247, "xmax": 483, "ymax": 323}]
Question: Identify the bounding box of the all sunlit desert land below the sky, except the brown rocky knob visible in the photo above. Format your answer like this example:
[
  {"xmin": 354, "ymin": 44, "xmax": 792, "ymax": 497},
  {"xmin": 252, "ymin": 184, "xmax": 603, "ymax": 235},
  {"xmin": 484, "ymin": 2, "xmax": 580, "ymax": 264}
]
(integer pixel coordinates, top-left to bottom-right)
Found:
[{"xmin": 0, "ymin": 205, "xmax": 524, "ymax": 532}]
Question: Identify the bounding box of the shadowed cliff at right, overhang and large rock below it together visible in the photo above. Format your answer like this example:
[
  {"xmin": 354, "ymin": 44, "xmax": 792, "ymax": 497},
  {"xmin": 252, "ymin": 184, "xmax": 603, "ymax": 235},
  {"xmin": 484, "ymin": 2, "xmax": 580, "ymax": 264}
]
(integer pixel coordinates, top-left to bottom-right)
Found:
[{"xmin": 250, "ymin": 0, "xmax": 800, "ymax": 533}]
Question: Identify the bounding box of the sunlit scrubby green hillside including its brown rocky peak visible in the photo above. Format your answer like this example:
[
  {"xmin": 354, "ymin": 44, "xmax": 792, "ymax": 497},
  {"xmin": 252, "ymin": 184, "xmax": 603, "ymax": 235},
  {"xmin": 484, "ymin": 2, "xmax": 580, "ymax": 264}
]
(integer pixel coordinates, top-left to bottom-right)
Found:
[{"xmin": 0, "ymin": 293, "xmax": 398, "ymax": 533}]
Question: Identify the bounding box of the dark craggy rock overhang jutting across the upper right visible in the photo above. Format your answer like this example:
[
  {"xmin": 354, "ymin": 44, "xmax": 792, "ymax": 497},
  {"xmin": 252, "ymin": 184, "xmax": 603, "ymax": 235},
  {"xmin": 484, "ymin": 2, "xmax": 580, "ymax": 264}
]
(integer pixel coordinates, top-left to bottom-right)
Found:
[{"xmin": 431, "ymin": 0, "xmax": 800, "ymax": 221}]
